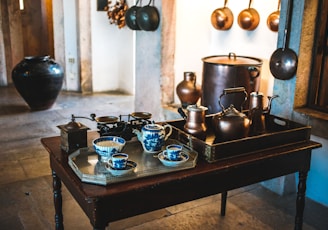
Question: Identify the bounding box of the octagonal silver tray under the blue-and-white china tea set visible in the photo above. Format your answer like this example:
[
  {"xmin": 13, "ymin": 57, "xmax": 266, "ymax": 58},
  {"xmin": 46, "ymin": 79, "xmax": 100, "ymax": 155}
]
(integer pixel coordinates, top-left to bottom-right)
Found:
[{"xmin": 68, "ymin": 139, "xmax": 198, "ymax": 185}]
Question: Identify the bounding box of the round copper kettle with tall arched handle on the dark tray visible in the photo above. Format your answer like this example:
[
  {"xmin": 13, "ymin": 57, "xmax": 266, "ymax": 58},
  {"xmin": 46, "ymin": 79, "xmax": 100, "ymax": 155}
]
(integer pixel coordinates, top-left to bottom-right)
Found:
[{"xmin": 212, "ymin": 87, "xmax": 251, "ymax": 141}]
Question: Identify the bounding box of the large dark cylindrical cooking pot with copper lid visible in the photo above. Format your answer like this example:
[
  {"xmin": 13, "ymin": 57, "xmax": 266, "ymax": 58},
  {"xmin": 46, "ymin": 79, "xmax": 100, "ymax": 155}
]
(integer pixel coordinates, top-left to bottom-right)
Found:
[{"xmin": 201, "ymin": 53, "xmax": 262, "ymax": 114}]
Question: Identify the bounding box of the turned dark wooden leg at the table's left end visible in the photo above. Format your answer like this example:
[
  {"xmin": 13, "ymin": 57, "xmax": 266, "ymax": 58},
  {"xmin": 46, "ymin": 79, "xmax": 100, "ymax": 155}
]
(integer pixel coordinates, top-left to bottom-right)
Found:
[{"xmin": 52, "ymin": 170, "xmax": 64, "ymax": 230}]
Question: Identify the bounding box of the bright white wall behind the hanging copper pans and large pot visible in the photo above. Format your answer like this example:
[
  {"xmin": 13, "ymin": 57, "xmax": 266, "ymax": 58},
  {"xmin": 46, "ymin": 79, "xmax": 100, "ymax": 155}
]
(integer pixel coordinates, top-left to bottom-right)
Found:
[{"xmin": 175, "ymin": 0, "xmax": 278, "ymax": 103}]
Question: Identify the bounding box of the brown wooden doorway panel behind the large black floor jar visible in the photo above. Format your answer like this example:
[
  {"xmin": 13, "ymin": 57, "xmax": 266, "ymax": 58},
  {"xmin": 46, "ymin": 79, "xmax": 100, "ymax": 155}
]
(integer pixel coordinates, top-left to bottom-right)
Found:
[{"xmin": 0, "ymin": 0, "xmax": 54, "ymax": 85}]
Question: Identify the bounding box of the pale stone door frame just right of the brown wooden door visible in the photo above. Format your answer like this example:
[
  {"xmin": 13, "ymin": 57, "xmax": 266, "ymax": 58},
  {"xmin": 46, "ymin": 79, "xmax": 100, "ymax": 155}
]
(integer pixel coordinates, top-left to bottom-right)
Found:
[{"xmin": 52, "ymin": 0, "xmax": 94, "ymax": 93}]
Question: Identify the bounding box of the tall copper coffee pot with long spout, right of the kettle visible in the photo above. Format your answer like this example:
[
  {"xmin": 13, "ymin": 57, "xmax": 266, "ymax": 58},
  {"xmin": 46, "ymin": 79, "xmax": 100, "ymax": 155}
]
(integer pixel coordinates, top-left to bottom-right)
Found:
[{"xmin": 248, "ymin": 92, "xmax": 278, "ymax": 135}]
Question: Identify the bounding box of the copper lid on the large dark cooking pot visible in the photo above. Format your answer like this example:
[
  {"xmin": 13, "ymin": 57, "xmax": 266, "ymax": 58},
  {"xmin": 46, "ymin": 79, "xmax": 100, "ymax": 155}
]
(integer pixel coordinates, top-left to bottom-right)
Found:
[{"xmin": 202, "ymin": 53, "xmax": 262, "ymax": 66}]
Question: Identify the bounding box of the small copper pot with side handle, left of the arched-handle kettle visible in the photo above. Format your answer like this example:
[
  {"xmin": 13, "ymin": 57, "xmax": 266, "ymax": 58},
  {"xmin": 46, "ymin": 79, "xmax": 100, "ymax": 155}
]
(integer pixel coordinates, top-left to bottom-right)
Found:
[{"xmin": 178, "ymin": 105, "xmax": 207, "ymax": 140}]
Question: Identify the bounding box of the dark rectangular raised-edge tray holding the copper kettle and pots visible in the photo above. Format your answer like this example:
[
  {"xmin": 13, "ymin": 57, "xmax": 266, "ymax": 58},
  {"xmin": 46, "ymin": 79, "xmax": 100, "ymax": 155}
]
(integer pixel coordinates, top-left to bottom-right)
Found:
[{"xmin": 167, "ymin": 115, "xmax": 311, "ymax": 163}]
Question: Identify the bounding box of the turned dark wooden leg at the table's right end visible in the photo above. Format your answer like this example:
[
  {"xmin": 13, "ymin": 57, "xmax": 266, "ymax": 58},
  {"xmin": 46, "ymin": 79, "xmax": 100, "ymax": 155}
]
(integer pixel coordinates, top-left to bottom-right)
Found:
[{"xmin": 295, "ymin": 171, "xmax": 308, "ymax": 230}]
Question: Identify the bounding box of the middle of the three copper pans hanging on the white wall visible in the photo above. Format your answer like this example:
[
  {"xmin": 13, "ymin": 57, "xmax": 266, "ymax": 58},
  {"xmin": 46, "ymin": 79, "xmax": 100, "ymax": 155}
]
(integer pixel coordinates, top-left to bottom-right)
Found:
[{"xmin": 238, "ymin": 0, "xmax": 260, "ymax": 30}]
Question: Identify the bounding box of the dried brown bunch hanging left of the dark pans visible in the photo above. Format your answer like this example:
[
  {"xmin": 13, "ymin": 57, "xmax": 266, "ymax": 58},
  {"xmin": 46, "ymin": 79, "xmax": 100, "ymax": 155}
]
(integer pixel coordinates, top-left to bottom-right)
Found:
[{"xmin": 107, "ymin": 0, "xmax": 129, "ymax": 29}]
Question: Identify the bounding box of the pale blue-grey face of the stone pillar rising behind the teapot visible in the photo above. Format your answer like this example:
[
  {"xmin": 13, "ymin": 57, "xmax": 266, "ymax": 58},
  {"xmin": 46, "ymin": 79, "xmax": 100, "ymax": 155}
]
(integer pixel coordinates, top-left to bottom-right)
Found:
[{"xmin": 135, "ymin": 1, "xmax": 163, "ymax": 121}]
